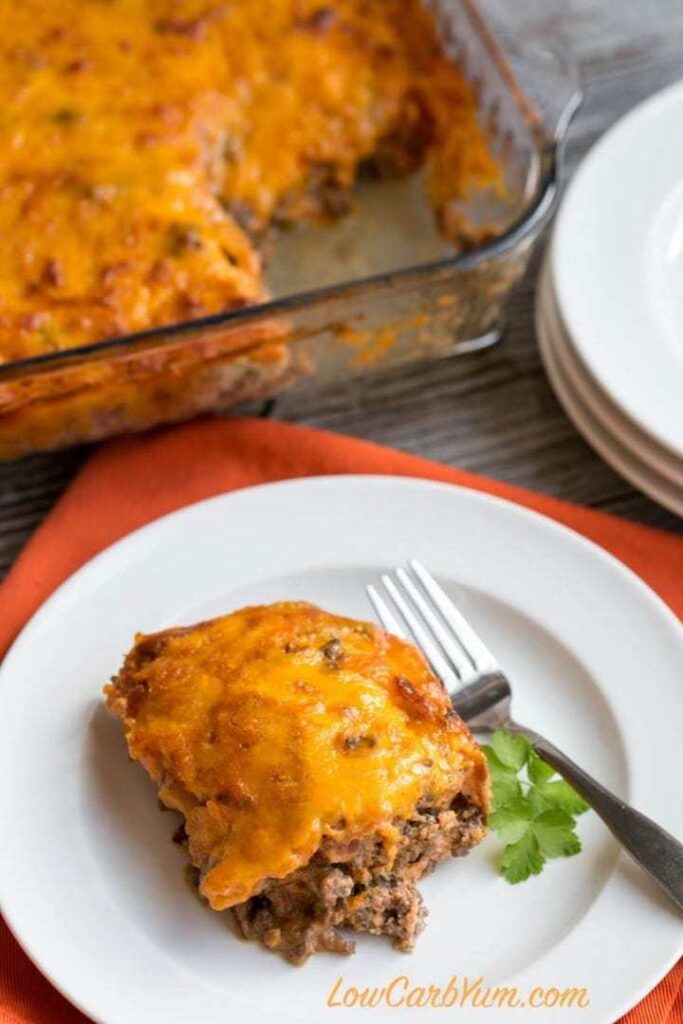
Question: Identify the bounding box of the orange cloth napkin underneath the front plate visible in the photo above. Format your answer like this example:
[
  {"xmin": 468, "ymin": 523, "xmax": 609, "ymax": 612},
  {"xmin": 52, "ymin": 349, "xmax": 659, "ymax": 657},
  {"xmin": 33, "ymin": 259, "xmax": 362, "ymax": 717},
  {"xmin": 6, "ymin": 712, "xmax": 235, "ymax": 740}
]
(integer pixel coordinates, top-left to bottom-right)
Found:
[{"xmin": 0, "ymin": 419, "xmax": 683, "ymax": 1024}]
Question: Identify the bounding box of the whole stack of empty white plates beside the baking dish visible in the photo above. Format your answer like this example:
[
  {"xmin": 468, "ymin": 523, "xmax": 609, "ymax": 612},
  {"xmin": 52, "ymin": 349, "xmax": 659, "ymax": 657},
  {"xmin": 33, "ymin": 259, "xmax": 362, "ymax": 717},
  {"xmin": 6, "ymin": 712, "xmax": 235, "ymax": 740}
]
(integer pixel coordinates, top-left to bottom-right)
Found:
[{"xmin": 537, "ymin": 83, "xmax": 683, "ymax": 515}]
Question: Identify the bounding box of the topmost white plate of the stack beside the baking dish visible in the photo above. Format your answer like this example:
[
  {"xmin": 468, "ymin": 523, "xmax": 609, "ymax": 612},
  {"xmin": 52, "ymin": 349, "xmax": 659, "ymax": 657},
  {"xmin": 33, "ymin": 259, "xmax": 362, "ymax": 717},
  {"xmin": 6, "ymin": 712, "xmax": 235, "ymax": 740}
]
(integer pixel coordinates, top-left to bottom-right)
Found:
[{"xmin": 551, "ymin": 83, "xmax": 683, "ymax": 457}]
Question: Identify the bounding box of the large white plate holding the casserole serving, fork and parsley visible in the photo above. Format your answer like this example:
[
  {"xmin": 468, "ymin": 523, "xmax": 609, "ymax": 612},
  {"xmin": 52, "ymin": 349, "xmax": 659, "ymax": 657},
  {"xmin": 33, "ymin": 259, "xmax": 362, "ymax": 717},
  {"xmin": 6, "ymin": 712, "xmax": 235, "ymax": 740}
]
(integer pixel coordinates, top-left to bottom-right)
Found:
[{"xmin": 0, "ymin": 476, "xmax": 683, "ymax": 1024}]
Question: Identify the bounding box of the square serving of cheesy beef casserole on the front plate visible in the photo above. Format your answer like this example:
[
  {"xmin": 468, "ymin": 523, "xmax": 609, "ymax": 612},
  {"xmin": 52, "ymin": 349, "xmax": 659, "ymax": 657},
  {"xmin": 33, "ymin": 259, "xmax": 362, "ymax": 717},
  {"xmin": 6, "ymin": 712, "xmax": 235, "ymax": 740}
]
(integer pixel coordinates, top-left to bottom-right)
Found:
[{"xmin": 105, "ymin": 602, "xmax": 489, "ymax": 964}]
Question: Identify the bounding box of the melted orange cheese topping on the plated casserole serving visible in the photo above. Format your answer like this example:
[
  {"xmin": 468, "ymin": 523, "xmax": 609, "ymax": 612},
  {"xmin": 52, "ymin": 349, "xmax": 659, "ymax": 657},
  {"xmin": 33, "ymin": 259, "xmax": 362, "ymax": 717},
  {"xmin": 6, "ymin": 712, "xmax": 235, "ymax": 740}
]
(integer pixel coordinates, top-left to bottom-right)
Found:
[{"xmin": 105, "ymin": 602, "xmax": 488, "ymax": 909}]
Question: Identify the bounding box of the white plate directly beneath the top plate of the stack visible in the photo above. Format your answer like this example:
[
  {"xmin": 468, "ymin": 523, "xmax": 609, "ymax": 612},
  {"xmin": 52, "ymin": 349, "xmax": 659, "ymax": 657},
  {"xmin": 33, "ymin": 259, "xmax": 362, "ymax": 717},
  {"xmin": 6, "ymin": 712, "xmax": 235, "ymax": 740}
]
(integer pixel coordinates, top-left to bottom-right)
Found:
[{"xmin": 537, "ymin": 260, "xmax": 683, "ymax": 494}]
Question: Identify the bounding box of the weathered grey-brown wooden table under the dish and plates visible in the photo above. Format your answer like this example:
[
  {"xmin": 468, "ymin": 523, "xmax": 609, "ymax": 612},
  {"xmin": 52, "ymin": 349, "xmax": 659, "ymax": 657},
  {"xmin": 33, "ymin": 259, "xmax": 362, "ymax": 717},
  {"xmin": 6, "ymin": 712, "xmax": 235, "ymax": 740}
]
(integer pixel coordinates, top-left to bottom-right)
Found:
[{"xmin": 0, "ymin": 0, "xmax": 683, "ymax": 571}]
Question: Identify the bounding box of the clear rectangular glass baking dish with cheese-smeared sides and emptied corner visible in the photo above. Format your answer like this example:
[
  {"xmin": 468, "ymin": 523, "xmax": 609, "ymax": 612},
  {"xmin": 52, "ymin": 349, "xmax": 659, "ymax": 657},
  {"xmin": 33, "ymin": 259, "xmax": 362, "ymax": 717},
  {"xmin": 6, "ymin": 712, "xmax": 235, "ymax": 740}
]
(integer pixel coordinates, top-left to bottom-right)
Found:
[{"xmin": 0, "ymin": 0, "xmax": 579, "ymax": 459}]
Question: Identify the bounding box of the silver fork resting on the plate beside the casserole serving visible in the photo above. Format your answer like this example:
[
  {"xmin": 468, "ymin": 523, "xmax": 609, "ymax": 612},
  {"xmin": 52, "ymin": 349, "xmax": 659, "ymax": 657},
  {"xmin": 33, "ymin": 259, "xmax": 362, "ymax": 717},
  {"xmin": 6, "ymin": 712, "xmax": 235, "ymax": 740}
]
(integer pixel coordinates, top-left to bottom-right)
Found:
[{"xmin": 367, "ymin": 560, "xmax": 683, "ymax": 909}]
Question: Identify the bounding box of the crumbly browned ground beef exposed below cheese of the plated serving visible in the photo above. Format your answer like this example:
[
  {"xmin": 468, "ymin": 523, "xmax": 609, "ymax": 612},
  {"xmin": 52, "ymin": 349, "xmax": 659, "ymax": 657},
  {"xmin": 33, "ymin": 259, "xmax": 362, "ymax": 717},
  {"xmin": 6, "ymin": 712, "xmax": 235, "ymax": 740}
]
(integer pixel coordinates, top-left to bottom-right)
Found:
[{"xmin": 232, "ymin": 795, "xmax": 485, "ymax": 964}]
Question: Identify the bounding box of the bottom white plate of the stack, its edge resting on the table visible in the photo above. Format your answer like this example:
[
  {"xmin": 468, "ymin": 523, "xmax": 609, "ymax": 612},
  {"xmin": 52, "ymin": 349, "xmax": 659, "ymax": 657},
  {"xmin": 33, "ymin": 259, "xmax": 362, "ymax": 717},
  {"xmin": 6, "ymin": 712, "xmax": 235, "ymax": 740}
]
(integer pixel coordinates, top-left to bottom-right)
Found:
[{"xmin": 536, "ymin": 272, "xmax": 683, "ymax": 516}]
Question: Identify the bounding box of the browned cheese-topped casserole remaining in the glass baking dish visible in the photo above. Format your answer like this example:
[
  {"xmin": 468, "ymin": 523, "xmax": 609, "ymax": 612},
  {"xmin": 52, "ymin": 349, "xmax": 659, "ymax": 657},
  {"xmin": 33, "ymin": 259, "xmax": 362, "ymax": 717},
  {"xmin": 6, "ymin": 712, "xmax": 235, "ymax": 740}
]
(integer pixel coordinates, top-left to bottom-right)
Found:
[{"xmin": 0, "ymin": 0, "xmax": 497, "ymax": 360}]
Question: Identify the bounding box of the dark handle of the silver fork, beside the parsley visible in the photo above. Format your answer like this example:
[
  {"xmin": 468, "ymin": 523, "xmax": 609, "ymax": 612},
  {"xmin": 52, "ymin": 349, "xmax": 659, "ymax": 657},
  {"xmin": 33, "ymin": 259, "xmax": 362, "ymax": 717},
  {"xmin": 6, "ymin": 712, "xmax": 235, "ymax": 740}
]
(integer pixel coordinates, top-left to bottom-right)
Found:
[{"xmin": 511, "ymin": 723, "xmax": 683, "ymax": 910}]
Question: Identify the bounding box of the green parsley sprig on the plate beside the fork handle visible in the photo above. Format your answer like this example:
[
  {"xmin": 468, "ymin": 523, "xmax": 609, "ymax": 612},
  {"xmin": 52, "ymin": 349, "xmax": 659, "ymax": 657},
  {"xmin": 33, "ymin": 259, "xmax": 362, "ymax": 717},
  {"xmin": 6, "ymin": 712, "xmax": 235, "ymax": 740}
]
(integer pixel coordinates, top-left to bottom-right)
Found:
[{"xmin": 481, "ymin": 729, "xmax": 588, "ymax": 885}]
